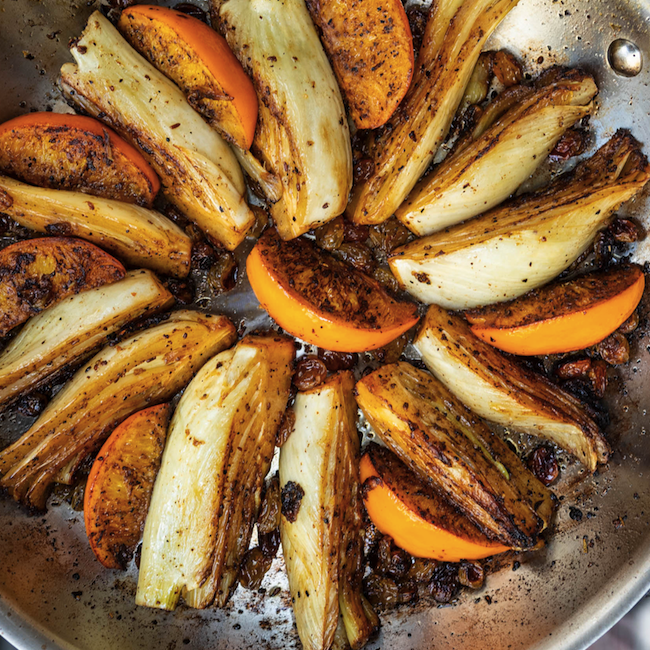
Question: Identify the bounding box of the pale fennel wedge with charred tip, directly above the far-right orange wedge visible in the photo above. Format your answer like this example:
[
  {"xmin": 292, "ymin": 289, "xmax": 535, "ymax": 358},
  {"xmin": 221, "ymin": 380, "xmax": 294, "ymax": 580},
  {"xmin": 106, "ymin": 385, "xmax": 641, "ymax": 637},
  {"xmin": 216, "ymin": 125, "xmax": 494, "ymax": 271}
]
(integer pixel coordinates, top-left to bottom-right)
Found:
[{"xmin": 389, "ymin": 131, "xmax": 650, "ymax": 309}]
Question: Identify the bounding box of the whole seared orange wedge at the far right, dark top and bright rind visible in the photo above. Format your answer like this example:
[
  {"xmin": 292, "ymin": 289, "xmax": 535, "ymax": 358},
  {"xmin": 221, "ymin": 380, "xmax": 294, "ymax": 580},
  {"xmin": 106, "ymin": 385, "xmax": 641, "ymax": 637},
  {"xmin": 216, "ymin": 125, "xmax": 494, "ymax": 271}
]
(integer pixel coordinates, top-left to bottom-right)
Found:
[{"xmin": 465, "ymin": 266, "xmax": 645, "ymax": 356}]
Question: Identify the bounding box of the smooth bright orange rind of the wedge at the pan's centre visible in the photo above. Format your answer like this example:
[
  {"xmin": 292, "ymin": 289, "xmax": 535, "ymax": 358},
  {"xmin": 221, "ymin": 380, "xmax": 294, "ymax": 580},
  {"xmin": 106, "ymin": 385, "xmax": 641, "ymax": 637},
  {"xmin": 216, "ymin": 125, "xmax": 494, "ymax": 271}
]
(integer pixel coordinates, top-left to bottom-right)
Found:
[{"xmin": 246, "ymin": 239, "xmax": 418, "ymax": 352}]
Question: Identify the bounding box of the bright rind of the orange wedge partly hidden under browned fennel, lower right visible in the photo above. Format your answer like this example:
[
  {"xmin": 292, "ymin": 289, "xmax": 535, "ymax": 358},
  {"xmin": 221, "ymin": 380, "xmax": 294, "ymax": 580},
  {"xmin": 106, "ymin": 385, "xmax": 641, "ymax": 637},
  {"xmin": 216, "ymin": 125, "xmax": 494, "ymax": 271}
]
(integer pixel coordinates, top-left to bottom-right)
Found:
[{"xmin": 360, "ymin": 454, "xmax": 509, "ymax": 562}]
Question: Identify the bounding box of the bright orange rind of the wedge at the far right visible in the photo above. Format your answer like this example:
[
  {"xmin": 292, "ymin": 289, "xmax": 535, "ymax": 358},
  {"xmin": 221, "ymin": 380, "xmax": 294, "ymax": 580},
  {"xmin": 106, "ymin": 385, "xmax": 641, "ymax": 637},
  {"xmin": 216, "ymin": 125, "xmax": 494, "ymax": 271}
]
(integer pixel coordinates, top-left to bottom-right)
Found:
[{"xmin": 471, "ymin": 275, "xmax": 645, "ymax": 356}]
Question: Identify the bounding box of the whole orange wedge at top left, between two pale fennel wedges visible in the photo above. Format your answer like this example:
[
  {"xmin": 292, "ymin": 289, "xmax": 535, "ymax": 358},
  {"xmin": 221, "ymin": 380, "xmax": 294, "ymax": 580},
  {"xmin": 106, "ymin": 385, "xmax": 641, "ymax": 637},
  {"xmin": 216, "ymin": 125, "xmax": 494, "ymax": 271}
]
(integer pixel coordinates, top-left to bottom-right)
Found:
[{"xmin": 118, "ymin": 5, "xmax": 257, "ymax": 149}]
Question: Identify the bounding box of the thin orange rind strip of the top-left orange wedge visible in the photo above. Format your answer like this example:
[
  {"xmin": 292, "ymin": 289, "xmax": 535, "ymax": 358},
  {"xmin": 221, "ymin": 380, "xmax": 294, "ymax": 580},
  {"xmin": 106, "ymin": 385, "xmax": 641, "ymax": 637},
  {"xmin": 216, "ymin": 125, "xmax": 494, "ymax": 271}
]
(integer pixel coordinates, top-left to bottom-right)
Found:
[{"xmin": 123, "ymin": 5, "xmax": 257, "ymax": 148}]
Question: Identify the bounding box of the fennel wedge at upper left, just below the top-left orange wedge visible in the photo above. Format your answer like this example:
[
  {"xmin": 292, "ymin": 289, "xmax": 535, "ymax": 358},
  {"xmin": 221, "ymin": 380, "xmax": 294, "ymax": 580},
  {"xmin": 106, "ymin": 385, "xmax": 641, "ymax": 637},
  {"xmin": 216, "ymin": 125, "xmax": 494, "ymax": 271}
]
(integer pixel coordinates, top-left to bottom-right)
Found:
[{"xmin": 60, "ymin": 11, "xmax": 255, "ymax": 250}]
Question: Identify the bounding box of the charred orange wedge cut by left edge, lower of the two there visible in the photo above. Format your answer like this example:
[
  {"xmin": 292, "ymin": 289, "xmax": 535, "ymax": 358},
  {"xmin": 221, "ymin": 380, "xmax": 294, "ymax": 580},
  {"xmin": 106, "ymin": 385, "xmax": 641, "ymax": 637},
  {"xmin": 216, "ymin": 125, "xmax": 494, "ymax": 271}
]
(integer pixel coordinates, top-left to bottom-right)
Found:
[{"xmin": 0, "ymin": 237, "xmax": 126, "ymax": 336}]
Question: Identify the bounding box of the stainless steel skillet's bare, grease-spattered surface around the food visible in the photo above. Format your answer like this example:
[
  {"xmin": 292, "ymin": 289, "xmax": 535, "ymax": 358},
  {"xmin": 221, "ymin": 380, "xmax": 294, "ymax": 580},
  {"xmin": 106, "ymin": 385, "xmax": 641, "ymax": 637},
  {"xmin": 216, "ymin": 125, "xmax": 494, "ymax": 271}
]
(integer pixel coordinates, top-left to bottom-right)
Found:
[{"xmin": 0, "ymin": 0, "xmax": 650, "ymax": 650}]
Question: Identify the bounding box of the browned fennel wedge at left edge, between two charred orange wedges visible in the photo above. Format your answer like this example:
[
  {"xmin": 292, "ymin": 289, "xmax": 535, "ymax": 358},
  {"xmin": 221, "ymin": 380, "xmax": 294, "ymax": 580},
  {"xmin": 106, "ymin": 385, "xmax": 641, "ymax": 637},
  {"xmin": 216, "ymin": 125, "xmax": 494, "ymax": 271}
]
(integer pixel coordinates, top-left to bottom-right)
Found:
[{"xmin": 0, "ymin": 176, "xmax": 192, "ymax": 278}]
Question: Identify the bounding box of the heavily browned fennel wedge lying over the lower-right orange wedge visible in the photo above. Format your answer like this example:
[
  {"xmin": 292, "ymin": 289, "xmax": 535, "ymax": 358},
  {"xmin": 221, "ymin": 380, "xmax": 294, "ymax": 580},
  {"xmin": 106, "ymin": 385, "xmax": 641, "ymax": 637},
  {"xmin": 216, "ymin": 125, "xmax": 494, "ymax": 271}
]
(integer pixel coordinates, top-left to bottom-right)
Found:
[{"xmin": 356, "ymin": 362, "xmax": 554, "ymax": 550}]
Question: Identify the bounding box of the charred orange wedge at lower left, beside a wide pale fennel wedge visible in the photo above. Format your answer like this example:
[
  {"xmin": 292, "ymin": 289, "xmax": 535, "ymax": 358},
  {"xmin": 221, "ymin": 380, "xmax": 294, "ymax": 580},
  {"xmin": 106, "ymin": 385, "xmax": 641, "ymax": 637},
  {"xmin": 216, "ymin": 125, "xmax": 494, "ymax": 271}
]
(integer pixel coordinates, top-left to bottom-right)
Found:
[{"xmin": 84, "ymin": 404, "xmax": 171, "ymax": 569}]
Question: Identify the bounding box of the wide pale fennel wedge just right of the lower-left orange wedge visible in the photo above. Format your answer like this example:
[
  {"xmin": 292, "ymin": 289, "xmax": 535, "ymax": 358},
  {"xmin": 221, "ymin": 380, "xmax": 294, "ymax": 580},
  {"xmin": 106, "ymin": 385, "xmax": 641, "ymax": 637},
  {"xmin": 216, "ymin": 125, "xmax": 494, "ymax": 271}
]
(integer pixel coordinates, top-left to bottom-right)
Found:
[{"xmin": 136, "ymin": 336, "xmax": 295, "ymax": 609}]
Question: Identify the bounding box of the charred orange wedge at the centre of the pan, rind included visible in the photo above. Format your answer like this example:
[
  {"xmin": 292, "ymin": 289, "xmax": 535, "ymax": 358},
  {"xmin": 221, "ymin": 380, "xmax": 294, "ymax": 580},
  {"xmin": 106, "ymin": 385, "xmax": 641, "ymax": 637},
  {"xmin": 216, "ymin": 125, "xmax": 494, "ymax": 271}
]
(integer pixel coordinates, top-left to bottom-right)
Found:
[{"xmin": 246, "ymin": 230, "xmax": 418, "ymax": 352}]
